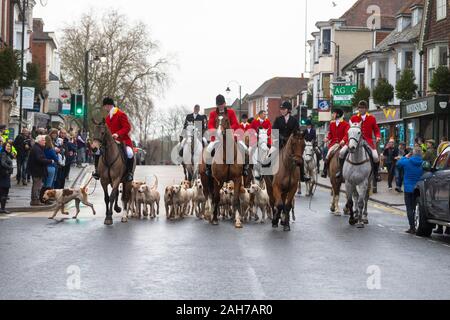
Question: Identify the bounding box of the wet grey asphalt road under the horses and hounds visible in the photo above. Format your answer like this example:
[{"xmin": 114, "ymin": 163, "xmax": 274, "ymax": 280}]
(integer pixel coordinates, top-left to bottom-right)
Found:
[{"xmin": 0, "ymin": 166, "xmax": 450, "ymax": 300}]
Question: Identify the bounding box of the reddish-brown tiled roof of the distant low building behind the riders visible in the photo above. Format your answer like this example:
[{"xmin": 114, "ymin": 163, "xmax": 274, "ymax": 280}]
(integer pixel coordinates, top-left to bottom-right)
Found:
[{"xmin": 249, "ymin": 77, "xmax": 309, "ymax": 99}]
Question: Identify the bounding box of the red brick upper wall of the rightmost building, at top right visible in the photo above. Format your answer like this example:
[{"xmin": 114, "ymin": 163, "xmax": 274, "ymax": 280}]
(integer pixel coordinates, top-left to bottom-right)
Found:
[{"xmin": 423, "ymin": 0, "xmax": 450, "ymax": 93}]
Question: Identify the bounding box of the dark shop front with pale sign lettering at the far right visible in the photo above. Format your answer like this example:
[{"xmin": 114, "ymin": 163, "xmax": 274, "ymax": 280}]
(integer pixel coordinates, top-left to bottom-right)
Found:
[{"xmin": 402, "ymin": 95, "xmax": 450, "ymax": 148}]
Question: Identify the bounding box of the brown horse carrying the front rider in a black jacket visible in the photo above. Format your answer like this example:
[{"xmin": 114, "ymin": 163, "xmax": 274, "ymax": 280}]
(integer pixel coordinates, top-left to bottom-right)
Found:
[{"xmin": 264, "ymin": 131, "xmax": 305, "ymax": 231}]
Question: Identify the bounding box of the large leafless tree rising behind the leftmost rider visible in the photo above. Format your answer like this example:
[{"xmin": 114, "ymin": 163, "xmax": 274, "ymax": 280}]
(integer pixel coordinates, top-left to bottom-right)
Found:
[{"xmin": 60, "ymin": 10, "xmax": 169, "ymax": 129}]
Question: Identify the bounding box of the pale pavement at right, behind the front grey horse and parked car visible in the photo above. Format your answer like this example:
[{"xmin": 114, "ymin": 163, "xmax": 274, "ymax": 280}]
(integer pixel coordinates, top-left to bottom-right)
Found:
[{"xmin": 312, "ymin": 175, "xmax": 406, "ymax": 212}]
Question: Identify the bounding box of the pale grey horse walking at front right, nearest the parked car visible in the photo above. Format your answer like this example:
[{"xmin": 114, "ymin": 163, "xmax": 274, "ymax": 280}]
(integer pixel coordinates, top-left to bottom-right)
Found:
[{"xmin": 343, "ymin": 123, "xmax": 373, "ymax": 228}]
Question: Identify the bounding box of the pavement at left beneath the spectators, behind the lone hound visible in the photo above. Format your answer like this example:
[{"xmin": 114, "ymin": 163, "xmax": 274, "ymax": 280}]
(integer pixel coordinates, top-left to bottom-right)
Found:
[{"xmin": 6, "ymin": 165, "xmax": 90, "ymax": 212}]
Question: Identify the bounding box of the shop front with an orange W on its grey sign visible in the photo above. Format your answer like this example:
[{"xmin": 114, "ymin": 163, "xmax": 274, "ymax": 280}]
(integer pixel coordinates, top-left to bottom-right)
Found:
[{"xmin": 370, "ymin": 107, "xmax": 405, "ymax": 149}]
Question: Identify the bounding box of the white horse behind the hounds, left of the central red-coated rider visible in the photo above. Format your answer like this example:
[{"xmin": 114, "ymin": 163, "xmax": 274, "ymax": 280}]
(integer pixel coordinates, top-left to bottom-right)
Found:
[{"xmin": 180, "ymin": 123, "xmax": 203, "ymax": 182}]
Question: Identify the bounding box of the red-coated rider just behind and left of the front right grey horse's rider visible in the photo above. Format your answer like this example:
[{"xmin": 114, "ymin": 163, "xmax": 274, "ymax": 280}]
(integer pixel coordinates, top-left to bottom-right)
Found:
[{"xmin": 322, "ymin": 109, "xmax": 350, "ymax": 178}]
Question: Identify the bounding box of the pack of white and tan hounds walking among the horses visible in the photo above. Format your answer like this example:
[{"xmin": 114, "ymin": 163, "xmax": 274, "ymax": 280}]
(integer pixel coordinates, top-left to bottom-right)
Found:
[{"xmin": 44, "ymin": 176, "xmax": 295, "ymax": 223}]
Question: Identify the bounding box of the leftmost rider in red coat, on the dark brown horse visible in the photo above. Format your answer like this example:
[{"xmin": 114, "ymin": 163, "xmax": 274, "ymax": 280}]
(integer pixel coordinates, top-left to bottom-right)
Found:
[{"xmin": 92, "ymin": 98, "xmax": 134, "ymax": 182}]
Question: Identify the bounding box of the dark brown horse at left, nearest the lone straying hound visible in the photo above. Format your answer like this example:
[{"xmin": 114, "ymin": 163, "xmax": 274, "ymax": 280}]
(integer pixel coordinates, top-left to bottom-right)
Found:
[{"xmin": 93, "ymin": 121, "xmax": 132, "ymax": 226}]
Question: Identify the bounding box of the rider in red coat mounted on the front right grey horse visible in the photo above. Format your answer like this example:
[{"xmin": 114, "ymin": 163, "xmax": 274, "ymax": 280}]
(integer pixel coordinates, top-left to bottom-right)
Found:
[{"xmin": 336, "ymin": 101, "xmax": 381, "ymax": 182}]
